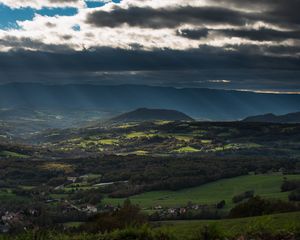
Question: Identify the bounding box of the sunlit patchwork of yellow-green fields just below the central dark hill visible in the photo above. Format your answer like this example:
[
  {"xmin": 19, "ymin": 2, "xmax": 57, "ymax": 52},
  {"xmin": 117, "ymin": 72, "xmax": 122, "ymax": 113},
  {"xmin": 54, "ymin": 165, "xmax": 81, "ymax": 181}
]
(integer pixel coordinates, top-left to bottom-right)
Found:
[{"xmin": 30, "ymin": 122, "xmax": 300, "ymax": 156}]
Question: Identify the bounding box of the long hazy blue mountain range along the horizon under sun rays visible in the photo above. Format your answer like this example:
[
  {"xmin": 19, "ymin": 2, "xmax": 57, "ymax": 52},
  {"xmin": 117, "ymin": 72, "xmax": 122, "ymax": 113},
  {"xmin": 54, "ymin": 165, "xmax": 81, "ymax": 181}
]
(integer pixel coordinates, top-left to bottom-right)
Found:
[{"xmin": 0, "ymin": 83, "xmax": 300, "ymax": 121}]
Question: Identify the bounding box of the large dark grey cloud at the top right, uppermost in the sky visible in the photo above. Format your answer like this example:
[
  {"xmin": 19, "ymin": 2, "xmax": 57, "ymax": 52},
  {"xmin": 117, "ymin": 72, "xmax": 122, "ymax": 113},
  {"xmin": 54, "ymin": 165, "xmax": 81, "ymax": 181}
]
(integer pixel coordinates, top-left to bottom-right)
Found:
[{"xmin": 87, "ymin": 0, "xmax": 300, "ymax": 28}]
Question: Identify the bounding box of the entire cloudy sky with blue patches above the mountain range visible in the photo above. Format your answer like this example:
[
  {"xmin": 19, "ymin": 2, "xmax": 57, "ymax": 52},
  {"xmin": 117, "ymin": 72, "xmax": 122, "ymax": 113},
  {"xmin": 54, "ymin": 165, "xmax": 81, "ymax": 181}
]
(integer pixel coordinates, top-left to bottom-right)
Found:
[{"xmin": 0, "ymin": 0, "xmax": 300, "ymax": 93}]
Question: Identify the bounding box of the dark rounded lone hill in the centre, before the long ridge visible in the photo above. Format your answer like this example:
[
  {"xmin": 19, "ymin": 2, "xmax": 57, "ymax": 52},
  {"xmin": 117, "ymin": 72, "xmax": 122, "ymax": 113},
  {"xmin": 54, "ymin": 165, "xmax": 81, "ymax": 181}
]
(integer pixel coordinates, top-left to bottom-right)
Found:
[{"xmin": 110, "ymin": 108, "xmax": 193, "ymax": 123}]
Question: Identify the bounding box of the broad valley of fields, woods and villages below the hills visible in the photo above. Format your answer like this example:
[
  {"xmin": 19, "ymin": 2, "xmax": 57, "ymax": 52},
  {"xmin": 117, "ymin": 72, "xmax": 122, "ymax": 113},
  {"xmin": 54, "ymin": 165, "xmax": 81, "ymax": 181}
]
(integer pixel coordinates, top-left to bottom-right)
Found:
[{"xmin": 0, "ymin": 119, "xmax": 300, "ymax": 236}]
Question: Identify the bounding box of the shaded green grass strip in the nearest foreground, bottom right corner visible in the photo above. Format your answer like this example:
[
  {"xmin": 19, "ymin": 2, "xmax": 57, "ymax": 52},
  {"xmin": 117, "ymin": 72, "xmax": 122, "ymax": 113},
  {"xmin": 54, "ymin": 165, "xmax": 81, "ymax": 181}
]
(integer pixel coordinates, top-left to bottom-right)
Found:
[{"xmin": 161, "ymin": 212, "xmax": 300, "ymax": 240}]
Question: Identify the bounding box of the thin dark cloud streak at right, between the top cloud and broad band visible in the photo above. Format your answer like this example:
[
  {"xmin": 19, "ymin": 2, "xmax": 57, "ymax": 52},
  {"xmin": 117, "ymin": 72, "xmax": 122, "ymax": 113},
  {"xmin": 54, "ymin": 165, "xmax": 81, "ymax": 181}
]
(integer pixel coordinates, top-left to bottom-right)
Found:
[{"xmin": 177, "ymin": 28, "xmax": 300, "ymax": 41}]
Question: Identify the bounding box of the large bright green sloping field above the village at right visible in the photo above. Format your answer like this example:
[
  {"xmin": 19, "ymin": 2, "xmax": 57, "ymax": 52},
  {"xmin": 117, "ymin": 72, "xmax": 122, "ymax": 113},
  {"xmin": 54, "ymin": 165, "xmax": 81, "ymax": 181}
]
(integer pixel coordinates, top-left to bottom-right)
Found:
[{"xmin": 104, "ymin": 173, "xmax": 300, "ymax": 209}]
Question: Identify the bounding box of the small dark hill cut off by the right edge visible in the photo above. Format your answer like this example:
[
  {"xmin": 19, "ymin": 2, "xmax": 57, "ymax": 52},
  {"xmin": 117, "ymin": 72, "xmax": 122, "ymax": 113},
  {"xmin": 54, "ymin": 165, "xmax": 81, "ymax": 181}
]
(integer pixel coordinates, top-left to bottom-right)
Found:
[{"xmin": 243, "ymin": 112, "xmax": 300, "ymax": 123}]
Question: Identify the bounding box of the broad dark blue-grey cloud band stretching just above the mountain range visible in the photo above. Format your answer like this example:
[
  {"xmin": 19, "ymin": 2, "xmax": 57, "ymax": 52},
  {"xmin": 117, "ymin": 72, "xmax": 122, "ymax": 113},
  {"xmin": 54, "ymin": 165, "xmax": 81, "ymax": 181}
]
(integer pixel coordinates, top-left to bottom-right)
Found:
[{"xmin": 0, "ymin": 46, "xmax": 300, "ymax": 90}]
